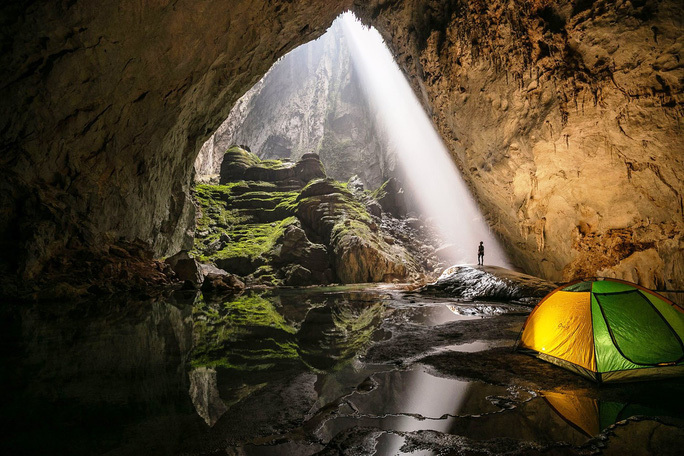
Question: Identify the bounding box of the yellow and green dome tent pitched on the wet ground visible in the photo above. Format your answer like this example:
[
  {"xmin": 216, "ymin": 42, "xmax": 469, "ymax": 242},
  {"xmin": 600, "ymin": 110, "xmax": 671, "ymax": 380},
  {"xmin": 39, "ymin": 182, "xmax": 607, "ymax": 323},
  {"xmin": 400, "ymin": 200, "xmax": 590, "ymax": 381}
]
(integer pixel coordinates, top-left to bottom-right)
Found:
[{"xmin": 516, "ymin": 279, "xmax": 684, "ymax": 382}]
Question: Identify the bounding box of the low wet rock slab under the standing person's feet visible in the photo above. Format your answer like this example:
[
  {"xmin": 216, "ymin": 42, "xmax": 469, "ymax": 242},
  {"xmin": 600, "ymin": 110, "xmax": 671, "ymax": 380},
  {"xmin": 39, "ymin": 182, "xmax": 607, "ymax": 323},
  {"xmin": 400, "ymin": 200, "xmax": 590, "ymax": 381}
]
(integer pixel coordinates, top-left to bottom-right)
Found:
[{"xmin": 422, "ymin": 265, "xmax": 556, "ymax": 300}]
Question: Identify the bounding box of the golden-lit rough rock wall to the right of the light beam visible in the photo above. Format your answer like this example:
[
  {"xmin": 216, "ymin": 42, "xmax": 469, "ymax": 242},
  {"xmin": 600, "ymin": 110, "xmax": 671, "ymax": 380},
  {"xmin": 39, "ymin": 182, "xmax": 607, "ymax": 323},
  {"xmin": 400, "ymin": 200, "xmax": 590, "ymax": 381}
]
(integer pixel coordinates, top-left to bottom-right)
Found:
[{"xmin": 366, "ymin": 0, "xmax": 684, "ymax": 288}]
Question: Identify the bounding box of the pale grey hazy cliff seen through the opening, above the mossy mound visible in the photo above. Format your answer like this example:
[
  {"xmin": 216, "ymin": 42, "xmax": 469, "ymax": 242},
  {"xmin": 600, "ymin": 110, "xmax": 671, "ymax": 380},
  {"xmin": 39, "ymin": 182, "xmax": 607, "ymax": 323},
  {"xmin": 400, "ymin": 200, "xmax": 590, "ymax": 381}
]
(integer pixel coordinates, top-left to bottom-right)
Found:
[{"xmin": 195, "ymin": 21, "xmax": 394, "ymax": 188}]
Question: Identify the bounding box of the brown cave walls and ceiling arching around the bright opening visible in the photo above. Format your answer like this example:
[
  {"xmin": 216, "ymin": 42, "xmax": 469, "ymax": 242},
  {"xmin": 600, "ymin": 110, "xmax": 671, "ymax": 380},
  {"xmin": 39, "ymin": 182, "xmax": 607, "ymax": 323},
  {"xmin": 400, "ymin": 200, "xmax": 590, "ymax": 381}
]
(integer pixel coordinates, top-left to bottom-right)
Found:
[{"xmin": 0, "ymin": 0, "xmax": 684, "ymax": 288}]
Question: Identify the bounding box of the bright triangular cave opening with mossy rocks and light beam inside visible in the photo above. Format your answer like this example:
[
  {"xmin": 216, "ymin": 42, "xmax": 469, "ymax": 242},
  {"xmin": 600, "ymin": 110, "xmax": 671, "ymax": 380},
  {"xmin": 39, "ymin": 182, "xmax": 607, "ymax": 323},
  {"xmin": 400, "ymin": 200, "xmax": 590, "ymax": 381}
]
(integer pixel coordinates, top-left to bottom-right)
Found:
[{"xmin": 192, "ymin": 12, "xmax": 509, "ymax": 284}]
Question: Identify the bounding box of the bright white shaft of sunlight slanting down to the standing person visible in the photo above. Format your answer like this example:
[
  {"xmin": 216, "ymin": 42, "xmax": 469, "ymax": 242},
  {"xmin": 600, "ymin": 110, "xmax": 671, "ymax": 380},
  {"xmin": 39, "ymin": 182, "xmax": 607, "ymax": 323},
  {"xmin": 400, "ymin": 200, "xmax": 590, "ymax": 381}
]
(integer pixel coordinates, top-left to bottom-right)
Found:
[{"xmin": 339, "ymin": 13, "xmax": 509, "ymax": 266}]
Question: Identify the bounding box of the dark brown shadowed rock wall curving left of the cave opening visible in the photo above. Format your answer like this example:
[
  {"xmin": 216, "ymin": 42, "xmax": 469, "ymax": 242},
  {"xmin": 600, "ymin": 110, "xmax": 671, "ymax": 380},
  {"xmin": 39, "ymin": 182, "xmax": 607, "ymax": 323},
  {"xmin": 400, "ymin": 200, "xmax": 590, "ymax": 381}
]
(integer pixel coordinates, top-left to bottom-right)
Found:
[{"xmin": 0, "ymin": 0, "xmax": 349, "ymax": 278}]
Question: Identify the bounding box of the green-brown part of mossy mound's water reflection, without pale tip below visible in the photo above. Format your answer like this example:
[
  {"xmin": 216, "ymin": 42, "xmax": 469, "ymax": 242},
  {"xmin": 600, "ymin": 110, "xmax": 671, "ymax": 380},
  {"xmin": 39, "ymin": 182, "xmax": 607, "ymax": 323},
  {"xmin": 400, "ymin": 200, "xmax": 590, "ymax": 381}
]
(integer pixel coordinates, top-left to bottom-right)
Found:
[{"xmin": 192, "ymin": 292, "xmax": 384, "ymax": 379}]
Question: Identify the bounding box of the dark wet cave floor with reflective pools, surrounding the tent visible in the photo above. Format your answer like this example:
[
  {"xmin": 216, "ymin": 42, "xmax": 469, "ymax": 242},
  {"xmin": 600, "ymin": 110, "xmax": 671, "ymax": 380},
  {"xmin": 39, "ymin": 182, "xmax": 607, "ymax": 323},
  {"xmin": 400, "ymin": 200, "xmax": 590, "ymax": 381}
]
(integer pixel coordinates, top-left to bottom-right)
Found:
[{"xmin": 0, "ymin": 285, "xmax": 684, "ymax": 455}]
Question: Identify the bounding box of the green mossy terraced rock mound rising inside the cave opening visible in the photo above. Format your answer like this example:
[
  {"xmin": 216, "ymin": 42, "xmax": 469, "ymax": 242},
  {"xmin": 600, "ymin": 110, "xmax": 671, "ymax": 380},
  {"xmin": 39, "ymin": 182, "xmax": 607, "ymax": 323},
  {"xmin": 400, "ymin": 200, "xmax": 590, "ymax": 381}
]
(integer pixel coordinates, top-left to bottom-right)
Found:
[{"xmin": 191, "ymin": 146, "xmax": 419, "ymax": 286}]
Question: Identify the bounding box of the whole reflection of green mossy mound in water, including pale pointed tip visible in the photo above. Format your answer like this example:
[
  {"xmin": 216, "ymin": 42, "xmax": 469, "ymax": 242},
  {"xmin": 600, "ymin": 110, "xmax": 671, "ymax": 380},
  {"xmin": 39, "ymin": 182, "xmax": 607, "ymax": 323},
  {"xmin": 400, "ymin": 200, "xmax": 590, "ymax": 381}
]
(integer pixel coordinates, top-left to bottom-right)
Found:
[{"xmin": 190, "ymin": 289, "xmax": 385, "ymax": 426}]
